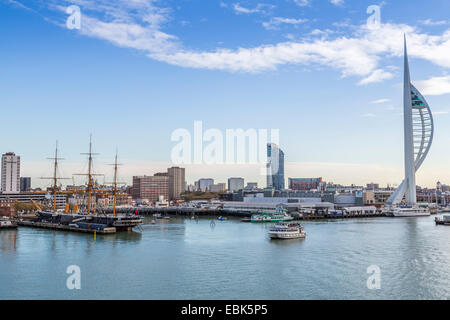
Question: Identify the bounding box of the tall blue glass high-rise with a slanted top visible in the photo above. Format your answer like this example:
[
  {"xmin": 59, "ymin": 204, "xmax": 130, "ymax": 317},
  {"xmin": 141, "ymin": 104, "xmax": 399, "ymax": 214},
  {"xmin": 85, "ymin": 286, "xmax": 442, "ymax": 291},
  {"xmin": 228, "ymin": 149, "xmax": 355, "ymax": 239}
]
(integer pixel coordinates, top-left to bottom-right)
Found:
[{"xmin": 267, "ymin": 143, "xmax": 284, "ymax": 190}]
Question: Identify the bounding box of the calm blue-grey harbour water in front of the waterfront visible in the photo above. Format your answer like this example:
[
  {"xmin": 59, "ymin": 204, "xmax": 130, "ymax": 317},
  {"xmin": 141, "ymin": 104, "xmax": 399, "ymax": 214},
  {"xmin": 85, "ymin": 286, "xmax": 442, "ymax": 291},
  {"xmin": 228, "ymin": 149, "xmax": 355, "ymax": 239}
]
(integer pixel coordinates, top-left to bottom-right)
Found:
[{"xmin": 0, "ymin": 217, "xmax": 450, "ymax": 299}]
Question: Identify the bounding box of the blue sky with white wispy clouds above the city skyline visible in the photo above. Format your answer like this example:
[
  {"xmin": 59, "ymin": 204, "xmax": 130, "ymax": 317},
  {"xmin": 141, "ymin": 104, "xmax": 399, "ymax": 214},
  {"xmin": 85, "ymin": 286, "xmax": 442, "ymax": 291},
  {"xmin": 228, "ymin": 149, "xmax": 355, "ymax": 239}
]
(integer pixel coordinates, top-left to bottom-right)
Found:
[{"xmin": 0, "ymin": 0, "xmax": 450, "ymax": 187}]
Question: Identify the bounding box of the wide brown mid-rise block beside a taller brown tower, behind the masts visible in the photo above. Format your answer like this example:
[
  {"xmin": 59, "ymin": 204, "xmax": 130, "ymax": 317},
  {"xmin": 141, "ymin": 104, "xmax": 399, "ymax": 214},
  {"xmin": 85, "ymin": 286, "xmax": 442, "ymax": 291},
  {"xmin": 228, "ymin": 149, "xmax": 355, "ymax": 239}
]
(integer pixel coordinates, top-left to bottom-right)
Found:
[{"xmin": 132, "ymin": 172, "xmax": 169, "ymax": 202}]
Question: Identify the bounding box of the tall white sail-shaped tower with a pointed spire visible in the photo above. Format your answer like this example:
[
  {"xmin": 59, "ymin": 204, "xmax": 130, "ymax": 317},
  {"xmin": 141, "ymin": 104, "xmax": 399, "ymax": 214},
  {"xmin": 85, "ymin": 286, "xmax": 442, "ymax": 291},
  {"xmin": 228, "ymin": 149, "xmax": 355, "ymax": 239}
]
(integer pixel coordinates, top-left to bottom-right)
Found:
[{"xmin": 388, "ymin": 36, "xmax": 434, "ymax": 205}]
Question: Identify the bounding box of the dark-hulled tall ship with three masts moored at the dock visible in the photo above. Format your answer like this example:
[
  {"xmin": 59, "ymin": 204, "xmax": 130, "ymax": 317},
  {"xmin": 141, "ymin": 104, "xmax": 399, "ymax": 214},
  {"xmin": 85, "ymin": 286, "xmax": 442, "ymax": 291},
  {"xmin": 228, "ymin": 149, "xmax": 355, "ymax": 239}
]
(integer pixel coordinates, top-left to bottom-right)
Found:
[{"xmin": 21, "ymin": 138, "xmax": 143, "ymax": 233}]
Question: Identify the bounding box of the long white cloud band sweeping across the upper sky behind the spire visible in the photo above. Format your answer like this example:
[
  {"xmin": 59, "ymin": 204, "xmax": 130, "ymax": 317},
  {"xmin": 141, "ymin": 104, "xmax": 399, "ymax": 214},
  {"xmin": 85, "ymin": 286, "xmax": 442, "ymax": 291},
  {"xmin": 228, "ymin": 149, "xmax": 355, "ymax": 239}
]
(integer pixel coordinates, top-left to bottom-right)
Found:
[{"xmin": 7, "ymin": 0, "xmax": 450, "ymax": 86}]
